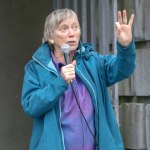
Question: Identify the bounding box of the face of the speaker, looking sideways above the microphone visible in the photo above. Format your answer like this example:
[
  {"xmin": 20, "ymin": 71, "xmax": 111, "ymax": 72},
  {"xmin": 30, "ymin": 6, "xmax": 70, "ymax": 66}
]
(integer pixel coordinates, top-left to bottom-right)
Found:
[{"xmin": 51, "ymin": 18, "xmax": 80, "ymax": 51}]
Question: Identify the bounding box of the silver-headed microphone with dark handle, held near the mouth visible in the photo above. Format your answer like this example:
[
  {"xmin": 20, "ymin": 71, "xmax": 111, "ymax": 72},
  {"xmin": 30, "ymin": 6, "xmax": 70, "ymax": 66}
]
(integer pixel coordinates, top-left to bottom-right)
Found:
[{"xmin": 61, "ymin": 44, "xmax": 71, "ymax": 64}]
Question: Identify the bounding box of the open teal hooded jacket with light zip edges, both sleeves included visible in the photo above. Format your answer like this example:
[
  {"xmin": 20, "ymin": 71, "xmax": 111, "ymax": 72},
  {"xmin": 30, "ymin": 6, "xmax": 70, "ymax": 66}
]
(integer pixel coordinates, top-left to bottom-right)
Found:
[{"xmin": 21, "ymin": 41, "xmax": 135, "ymax": 150}]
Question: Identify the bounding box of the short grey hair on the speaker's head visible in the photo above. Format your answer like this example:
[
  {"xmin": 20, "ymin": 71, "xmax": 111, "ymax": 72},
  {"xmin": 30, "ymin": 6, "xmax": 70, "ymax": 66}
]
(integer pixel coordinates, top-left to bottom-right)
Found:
[{"xmin": 42, "ymin": 8, "xmax": 79, "ymax": 43}]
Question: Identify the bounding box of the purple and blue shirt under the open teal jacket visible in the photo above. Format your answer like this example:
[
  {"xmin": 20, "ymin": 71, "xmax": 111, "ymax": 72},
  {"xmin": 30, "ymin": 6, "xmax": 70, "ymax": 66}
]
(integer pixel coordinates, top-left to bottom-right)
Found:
[{"xmin": 51, "ymin": 53, "xmax": 95, "ymax": 150}]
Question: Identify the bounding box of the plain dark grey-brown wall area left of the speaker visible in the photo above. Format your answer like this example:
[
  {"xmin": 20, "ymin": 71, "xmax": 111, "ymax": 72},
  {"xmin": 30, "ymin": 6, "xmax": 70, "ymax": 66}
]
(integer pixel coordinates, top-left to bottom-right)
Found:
[{"xmin": 0, "ymin": 0, "xmax": 53, "ymax": 150}]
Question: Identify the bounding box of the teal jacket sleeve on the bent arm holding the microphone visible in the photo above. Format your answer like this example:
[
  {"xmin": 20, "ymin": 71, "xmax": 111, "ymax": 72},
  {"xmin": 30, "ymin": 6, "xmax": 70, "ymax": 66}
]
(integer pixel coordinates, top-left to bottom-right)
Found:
[{"xmin": 21, "ymin": 61, "xmax": 68, "ymax": 118}]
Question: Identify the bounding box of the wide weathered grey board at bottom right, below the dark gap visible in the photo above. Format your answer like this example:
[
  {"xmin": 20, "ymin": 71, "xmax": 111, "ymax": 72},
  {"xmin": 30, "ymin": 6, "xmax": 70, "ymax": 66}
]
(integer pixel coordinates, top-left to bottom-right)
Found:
[{"xmin": 121, "ymin": 103, "xmax": 146, "ymax": 150}]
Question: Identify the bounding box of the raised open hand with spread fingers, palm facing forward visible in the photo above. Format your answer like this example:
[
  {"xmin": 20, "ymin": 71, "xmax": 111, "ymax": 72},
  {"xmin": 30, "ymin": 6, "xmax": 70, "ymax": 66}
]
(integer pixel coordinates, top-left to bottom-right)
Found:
[{"xmin": 116, "ymin": 10, "xmax": 134, "ymax": 46}]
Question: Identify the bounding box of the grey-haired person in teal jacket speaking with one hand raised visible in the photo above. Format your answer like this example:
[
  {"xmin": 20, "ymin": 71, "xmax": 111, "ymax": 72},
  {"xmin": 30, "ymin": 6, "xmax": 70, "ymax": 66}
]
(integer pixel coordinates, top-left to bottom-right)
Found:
[{"xmin": 22, "ymin": 9, "xmax": 135, "ymax": 150}]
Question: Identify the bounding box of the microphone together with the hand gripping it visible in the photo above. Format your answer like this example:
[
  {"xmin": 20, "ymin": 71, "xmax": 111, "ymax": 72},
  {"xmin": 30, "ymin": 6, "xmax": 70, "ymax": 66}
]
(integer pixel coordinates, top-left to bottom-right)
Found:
[{"xmin": 61, "ymin": 44, "xmax": 76, "ymax": 84}]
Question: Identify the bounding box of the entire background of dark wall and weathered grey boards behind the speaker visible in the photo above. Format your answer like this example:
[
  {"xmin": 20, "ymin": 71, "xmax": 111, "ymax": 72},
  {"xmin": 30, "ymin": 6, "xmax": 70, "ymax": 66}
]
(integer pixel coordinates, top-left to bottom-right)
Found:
[{"xmin": 0, "ymin": 0, "xmax": 150, "ymax": 150}]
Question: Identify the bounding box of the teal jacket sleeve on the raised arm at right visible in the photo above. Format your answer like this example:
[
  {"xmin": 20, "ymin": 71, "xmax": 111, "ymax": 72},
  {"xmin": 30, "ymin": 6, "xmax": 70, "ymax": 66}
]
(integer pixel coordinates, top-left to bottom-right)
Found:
[{"xmin": 104, "ymin": 41, "xmax": 136, "ymax": 86}]
